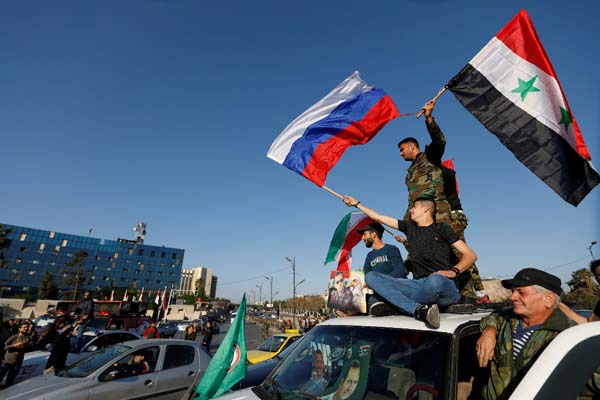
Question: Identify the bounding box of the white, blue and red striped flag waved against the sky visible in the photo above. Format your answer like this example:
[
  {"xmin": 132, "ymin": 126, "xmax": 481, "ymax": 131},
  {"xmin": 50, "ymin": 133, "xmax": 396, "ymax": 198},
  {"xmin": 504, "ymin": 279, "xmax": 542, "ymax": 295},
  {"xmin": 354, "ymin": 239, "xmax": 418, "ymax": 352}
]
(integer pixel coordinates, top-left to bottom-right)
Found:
[{"xmin": 267, "ymin": 71, "xmax": 400, "ymax": 186}]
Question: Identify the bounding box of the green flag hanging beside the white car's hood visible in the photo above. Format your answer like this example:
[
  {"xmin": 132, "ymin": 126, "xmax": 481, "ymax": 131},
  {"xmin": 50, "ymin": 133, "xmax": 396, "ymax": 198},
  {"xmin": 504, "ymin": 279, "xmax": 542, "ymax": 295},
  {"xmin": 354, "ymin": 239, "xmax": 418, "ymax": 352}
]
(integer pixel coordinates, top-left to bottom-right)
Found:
[{"xmin": 195, "ymin": 293, "xmax": 246, "ymax": 400}]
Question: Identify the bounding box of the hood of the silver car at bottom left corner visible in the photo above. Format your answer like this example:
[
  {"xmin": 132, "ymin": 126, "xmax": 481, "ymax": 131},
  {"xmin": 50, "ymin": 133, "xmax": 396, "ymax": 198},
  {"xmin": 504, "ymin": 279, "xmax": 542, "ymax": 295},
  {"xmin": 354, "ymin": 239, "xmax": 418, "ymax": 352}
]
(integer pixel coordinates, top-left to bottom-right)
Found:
[{"xmin": 0, "ymin": 374, "xmax": 89, "ymax": 400}]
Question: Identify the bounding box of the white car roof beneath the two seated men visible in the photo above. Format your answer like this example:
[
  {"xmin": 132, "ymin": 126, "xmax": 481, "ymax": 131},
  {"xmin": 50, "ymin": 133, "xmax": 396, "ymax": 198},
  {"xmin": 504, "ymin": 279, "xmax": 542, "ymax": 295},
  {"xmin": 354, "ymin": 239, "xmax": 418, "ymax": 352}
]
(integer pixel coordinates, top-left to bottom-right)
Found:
[{"xmin": 319, "ymin": 310, "xmax": 491, "ymax": 333}]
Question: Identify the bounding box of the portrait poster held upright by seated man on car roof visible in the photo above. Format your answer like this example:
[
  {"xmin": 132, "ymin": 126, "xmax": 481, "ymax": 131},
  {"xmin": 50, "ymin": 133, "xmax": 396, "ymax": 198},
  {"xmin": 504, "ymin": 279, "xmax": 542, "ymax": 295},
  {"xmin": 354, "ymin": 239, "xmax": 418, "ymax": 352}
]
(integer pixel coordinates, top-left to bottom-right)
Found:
[{"xmin": 327, "ymin": 270, "xmax": 367, "ymax": 315}]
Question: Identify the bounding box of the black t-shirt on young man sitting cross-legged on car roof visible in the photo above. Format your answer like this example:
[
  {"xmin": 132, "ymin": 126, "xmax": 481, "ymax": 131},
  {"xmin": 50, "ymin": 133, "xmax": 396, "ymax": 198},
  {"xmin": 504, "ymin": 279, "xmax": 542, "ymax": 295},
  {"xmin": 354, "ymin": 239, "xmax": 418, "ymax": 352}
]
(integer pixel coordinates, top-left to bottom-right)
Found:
[{"xmin": 398, "ymin": 220, "xmax": 460, "ymax": 279}]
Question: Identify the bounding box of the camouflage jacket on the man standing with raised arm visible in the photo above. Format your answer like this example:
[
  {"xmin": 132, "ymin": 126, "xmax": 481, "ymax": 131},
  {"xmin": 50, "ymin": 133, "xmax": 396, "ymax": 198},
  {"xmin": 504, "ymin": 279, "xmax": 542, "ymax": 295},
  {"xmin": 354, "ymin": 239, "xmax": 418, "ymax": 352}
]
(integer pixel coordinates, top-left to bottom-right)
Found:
[{"xmin": 404, "ymin": 120, "xmax": 451, "ymax": 224}]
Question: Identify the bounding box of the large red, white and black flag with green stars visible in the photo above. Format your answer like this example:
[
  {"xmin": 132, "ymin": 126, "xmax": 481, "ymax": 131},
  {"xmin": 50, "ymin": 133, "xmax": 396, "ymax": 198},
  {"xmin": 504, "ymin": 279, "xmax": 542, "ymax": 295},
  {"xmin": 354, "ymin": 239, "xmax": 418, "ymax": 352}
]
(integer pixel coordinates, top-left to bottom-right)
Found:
[{"xmin": 448, "ymin": 10, "xmax": 600, "ymax": 206}]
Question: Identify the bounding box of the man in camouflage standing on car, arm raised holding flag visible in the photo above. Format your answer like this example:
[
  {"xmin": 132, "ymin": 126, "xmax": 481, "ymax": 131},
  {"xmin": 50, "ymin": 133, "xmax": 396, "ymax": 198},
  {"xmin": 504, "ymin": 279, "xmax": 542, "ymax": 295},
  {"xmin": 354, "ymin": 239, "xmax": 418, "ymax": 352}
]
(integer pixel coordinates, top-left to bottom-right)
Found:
[{"xmin": 397, "ymin": 100, "xmax": 483, "ymax": 302}]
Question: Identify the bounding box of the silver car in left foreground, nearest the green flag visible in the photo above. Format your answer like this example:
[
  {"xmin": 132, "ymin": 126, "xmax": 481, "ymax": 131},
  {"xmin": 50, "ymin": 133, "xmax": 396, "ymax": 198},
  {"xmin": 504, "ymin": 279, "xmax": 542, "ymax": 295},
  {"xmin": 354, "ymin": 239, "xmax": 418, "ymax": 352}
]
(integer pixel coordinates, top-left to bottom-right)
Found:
[{"xmin": 1, "ymin": 339, "xmax": 210, "ymax": 400}]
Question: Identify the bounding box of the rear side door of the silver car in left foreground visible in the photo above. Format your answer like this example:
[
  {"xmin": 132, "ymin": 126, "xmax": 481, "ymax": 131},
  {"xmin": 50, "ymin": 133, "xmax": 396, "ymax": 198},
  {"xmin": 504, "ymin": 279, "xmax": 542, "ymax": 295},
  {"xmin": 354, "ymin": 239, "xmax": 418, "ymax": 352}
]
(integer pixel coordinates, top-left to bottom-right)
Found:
[{"xmin": 155, "ymin": 344, "xmax": 200, "ymax": 400}]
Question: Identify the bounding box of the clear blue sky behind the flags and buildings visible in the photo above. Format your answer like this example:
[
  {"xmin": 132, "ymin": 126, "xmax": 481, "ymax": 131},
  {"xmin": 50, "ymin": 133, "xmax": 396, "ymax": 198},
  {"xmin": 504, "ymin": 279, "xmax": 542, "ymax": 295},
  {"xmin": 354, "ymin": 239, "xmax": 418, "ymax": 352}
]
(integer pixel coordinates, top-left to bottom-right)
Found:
[{"xmin": 0, "ymin": 0, "xmax": 600, "ymax": 300}]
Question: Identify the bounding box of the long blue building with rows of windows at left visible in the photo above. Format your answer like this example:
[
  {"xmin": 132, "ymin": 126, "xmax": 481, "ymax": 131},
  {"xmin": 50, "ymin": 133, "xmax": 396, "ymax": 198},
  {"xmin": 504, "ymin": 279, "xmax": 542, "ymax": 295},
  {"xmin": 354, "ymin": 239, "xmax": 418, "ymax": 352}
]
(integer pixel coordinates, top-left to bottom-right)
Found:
[{"xmin": 0, "ymin": 224, "xmax": 185, "ymax": 297}]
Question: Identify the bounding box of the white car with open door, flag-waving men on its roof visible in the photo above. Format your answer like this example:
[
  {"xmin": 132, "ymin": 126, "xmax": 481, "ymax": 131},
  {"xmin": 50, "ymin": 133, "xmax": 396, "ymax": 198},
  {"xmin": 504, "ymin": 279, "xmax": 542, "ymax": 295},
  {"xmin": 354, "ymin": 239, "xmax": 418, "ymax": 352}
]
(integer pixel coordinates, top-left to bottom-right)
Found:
[{"xmin": 213, "ymin": 311, "xmax": 600, "ymax": 400}]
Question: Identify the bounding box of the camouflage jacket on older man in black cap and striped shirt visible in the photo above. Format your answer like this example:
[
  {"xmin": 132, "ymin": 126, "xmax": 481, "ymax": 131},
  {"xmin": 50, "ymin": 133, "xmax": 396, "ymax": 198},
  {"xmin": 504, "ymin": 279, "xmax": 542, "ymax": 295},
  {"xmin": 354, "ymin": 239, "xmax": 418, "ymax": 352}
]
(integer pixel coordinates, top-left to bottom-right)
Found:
[{"xmin": 479, "ymin": 309, "xmax": 575, "ymax": 400}]
